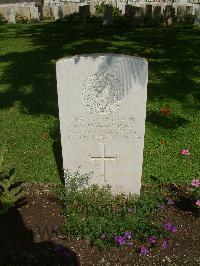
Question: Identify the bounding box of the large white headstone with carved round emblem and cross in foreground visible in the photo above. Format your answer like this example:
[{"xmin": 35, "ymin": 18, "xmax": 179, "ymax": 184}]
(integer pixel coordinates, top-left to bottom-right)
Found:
[{"xmin": 56, "ymin": 54, "xmax": 148, "ymax": 194}]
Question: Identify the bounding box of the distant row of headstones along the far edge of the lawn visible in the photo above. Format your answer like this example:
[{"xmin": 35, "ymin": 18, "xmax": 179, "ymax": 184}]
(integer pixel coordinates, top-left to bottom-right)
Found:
[{"xmin": 0, "ymin": 1, "xmax": 200, "ymax": 26}]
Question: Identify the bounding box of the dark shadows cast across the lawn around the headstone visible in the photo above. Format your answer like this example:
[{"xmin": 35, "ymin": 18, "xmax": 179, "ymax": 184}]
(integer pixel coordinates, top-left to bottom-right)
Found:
[{"xmin": 0, "ymin": 22, "xmax": 200, "ymax": 182}]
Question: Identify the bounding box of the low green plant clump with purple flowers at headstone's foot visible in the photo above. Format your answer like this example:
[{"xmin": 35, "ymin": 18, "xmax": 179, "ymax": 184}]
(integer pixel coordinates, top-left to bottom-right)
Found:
[{"xmin": 56, "ymin": 171, "xmax": 181, "ymax": 255}]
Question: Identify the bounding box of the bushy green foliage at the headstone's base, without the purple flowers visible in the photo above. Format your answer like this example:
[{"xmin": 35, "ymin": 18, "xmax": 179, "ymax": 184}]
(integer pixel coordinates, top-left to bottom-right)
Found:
[{"xmin": 57, "ymin": 172, "xmax": 168, "ymax": 247}]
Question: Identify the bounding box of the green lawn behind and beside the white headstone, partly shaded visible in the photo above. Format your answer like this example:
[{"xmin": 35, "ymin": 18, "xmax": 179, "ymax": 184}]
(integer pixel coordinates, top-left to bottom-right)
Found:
[{"xmin": 0, "ymin": 23, "xmax": 200, "ymax": 184}]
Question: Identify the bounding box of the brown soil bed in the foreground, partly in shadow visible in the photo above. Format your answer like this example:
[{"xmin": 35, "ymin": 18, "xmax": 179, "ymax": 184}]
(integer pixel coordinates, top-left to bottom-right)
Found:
[{"xmin": 0, "ymin": 184, "xmax": 200, "ymax": 266}]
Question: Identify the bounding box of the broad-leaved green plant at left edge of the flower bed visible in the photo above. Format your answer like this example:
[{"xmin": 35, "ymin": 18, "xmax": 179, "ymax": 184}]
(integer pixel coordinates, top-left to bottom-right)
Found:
[{"xmin": 0, "ymin": 150, "xmax": 24, "ymax": 214}]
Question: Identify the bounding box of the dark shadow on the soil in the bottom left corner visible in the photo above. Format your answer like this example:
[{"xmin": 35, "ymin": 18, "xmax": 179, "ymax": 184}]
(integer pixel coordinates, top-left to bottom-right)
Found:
[{"xmin": 0, "ymin": 204, "xmax": 80, "ymax": 266}]
